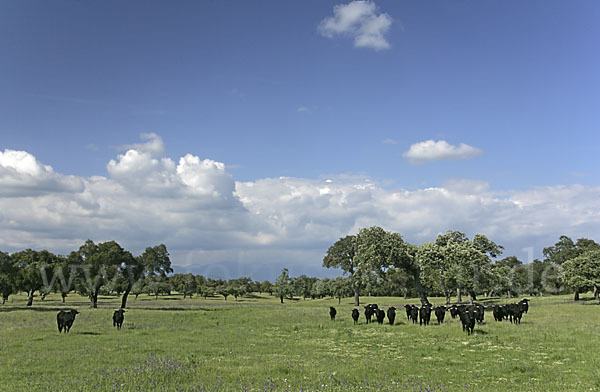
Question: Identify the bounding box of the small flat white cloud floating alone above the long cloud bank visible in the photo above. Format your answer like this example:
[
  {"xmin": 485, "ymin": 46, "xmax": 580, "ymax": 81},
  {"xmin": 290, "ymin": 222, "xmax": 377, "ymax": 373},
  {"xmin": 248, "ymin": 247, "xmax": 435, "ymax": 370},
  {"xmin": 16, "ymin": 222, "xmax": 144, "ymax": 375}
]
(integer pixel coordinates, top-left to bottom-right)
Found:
[{"xmin": 402, "ymin": 140, "xmax": 482, "ymax": 163}]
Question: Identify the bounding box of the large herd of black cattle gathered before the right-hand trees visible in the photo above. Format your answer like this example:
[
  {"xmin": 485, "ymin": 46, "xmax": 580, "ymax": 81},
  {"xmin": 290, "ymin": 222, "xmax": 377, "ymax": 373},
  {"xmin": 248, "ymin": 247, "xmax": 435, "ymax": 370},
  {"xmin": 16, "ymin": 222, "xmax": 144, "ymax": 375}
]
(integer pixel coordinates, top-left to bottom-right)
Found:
[{"xmin": 329, "ymin": 298, "xmax": 529, "ymax": 335}]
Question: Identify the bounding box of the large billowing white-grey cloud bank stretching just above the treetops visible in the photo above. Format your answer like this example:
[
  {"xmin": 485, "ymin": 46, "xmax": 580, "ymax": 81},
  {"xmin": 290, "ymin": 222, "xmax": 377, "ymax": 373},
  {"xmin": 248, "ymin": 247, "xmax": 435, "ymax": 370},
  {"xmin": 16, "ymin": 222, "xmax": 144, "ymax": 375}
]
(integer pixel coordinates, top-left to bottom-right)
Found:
[{"xmin": 0, "ymin": 135, "xmax": 600, "ymax": 279}]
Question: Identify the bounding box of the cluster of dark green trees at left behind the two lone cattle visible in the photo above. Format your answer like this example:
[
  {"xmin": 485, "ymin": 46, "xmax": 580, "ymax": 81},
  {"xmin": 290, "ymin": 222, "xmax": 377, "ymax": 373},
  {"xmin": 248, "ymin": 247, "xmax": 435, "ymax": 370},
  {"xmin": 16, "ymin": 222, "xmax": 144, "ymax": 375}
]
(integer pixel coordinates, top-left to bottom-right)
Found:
[{"xmin": 0, "ymin": 240, "xmax": 173, "ymax": 308}]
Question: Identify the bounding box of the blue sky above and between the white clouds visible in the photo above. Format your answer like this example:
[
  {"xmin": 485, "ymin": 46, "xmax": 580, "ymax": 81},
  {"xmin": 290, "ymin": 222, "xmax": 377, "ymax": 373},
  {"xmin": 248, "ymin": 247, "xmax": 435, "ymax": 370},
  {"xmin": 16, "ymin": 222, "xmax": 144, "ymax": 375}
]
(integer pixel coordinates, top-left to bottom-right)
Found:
[{"xmin": 0, "ymin": 0, "xmax": 600, "ymax": 280}]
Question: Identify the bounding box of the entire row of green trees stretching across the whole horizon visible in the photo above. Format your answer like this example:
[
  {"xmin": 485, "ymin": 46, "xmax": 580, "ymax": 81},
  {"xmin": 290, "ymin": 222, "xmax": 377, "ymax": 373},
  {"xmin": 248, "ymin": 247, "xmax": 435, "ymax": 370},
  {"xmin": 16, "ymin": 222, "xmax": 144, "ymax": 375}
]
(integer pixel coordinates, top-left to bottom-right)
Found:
[{"xmin": 0, "ymin": 230, "xmax": 600, "ymax": 308}]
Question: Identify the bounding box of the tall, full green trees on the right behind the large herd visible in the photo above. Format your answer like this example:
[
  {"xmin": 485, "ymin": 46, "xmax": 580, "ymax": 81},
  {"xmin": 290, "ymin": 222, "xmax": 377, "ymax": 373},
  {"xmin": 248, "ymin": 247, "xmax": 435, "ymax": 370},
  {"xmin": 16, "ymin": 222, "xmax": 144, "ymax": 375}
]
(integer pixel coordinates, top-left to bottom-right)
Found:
[{"xmin": 323, "ymin": 226, "xmax": 600, "ymax": 306}]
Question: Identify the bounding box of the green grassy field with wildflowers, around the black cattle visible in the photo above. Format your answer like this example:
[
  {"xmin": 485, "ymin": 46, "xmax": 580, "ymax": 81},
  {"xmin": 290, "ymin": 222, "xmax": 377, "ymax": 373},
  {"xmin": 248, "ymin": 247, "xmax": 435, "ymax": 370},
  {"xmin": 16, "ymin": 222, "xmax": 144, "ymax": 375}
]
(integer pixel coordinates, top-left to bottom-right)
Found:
[{"xmin": 0, "ymin": 295, "xmax": 600, "ymax": 391}]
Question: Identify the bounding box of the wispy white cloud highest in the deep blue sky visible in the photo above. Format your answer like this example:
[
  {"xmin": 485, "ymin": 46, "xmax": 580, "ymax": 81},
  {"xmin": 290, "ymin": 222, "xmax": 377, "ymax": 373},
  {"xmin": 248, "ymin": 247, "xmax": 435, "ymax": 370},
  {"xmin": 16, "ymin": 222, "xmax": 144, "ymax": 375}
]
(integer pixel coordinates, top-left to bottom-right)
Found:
[{"xmin": 318, "ymin": 1, "xmax": 392, "ymax": 50}]
